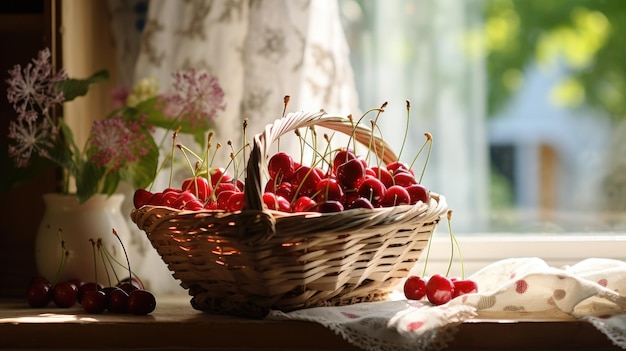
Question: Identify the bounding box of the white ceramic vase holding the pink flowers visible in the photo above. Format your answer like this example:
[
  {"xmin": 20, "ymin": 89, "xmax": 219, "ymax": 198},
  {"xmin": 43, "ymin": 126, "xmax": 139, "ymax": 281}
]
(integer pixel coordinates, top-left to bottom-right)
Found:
[{"xmin": 35, "ymin": 193, "xmax": 132, "ymax": 286}]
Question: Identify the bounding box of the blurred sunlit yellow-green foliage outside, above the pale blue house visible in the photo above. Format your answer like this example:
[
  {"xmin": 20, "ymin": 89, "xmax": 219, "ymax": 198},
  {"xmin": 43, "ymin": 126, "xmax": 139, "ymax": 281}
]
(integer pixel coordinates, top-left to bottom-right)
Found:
[{"xmin": 483, "ymin": 0, "xmax": 626, "ymax": 119}]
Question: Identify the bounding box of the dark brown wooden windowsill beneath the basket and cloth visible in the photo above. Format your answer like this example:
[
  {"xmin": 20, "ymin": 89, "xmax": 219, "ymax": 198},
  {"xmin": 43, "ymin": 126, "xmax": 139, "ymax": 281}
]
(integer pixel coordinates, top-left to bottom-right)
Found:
[{"xmin": 0, "ymin": 296, "xmax": 620, "ymax": 350}]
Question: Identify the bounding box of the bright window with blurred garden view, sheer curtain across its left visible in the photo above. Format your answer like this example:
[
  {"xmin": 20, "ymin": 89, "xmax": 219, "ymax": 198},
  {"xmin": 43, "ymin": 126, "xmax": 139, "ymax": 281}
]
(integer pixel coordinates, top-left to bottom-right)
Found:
[{"xmin": 340, "ymin": 0, "xmax": 626, "ymax": 276}]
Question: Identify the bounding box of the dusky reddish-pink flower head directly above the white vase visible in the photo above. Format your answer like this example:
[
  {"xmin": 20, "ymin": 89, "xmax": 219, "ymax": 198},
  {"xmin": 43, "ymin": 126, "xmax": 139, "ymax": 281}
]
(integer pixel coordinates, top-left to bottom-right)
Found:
[{"xmin": 89, "ymin": 116, "xmax": 151, "ymax": 171}]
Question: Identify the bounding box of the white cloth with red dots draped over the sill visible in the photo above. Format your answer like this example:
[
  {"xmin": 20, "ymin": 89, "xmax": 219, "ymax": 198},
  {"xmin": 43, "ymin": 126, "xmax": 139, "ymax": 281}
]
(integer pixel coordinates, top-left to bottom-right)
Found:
[{"xmin": 267, "ymin": 258, "xmax": 626, "ymax": 351}]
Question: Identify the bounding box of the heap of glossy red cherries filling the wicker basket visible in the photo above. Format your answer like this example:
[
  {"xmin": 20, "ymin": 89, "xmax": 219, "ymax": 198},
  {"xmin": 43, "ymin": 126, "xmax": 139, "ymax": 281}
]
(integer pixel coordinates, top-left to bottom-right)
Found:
[{"xmin": 134, "ymin": 149, "xmax": 430, "ymax": 213}]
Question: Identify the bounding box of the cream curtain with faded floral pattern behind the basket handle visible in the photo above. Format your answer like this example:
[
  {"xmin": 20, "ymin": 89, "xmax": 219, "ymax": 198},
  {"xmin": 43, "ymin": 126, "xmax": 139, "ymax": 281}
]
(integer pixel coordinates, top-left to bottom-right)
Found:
[{"xmin": 109, "ymin": 0, "xmax": 358, "ymax": 293}]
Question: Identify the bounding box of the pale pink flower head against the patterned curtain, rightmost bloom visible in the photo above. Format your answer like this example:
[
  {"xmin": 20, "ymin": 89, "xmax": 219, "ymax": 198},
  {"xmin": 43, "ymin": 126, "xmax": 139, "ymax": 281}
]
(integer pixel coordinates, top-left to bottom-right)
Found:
[{"xmin": 162, "ymin": 68, "xmax": 226, "ymax": 128}]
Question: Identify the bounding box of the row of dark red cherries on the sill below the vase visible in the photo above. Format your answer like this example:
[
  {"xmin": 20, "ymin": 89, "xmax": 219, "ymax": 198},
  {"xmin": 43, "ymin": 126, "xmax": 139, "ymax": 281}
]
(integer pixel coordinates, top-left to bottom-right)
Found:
[{"xmin": 27, "ymin": 276, "xmax": 156, "ymax": 315}]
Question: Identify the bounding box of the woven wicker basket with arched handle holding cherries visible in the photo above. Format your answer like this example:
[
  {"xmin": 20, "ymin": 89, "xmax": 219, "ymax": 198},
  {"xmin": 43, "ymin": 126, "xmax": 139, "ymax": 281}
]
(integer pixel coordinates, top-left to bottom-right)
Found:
[{"xmin": 131, "ymin": 112, "xmax": 447, "ymax": 318}]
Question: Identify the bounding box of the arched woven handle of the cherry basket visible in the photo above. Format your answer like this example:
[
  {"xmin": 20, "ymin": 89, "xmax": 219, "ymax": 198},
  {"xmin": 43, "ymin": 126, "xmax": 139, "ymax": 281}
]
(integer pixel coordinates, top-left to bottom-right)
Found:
[{"xmin": 244, "ymin": 112, "xmax": 397, "ymax": 211}]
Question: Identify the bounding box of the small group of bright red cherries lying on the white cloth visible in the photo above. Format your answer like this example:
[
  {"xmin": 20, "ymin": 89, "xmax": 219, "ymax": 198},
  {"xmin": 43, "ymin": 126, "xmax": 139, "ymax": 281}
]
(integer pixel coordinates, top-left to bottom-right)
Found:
[{"xmin": 404, "ymin": 274, "xmax": 478, "ymax": 305}]
